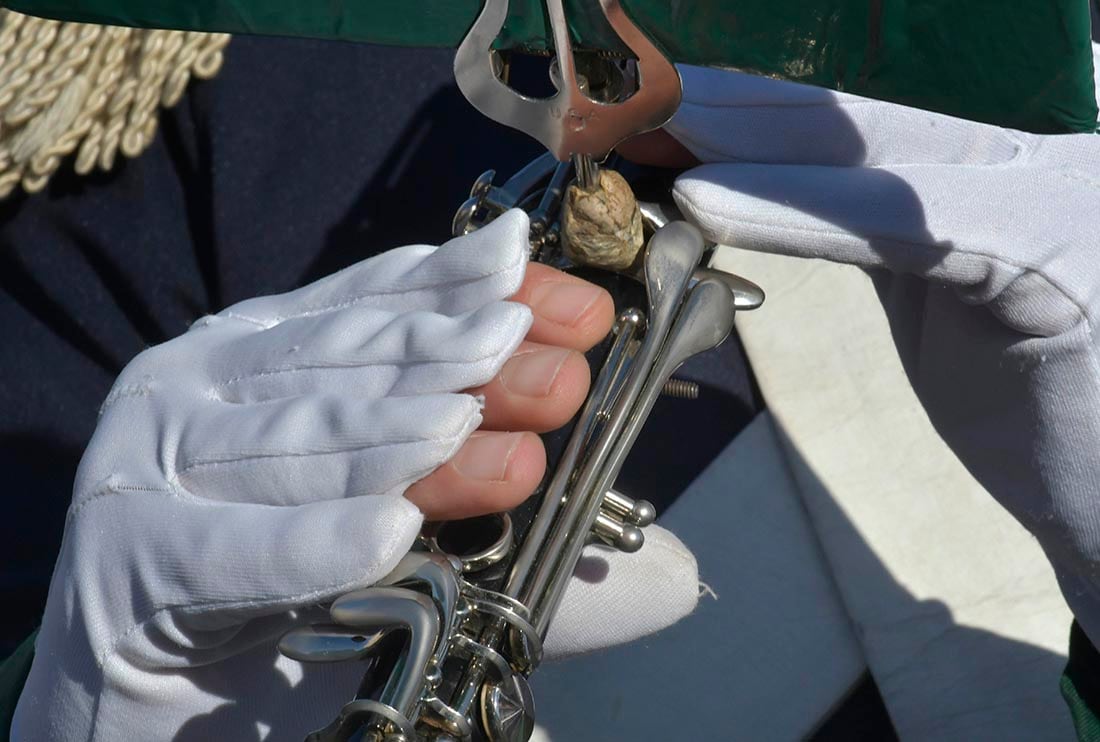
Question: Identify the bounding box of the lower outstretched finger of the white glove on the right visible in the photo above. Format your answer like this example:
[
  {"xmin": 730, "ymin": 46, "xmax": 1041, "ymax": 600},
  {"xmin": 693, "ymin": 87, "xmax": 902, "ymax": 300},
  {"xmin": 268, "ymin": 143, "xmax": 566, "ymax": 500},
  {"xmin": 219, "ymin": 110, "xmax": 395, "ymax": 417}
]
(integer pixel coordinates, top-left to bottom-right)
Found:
[{"xmin": 673, "ymin": 164, "xmax": 1100, "ymax": 335}]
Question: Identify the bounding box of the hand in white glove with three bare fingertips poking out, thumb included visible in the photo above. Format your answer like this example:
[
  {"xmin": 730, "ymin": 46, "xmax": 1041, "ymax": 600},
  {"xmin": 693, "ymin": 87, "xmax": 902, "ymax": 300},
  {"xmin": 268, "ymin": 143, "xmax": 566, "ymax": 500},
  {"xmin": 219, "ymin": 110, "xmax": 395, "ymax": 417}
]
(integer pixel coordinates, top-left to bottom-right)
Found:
[{"xmin": 13, "ymin": 211, "xmax": 697, "ymax": 742}]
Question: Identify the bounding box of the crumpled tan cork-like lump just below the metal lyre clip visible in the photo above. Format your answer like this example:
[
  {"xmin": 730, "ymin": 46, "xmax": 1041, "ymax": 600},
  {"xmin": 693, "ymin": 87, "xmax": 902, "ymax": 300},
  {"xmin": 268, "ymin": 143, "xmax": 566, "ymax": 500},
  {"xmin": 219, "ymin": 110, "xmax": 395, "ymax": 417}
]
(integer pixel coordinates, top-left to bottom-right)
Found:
[{"xmin": 561, "ymin": 168, "xmax": 645, "ymax": 270}]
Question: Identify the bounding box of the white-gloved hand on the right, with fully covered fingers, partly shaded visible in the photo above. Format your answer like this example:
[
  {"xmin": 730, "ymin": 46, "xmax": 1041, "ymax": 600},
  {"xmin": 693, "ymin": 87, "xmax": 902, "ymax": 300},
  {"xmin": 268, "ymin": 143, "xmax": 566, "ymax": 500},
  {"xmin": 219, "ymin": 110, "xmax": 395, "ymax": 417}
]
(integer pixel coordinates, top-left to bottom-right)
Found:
[{"xmin": 669, "ymin": 63, "xmax": 1100, "ymax": 644}]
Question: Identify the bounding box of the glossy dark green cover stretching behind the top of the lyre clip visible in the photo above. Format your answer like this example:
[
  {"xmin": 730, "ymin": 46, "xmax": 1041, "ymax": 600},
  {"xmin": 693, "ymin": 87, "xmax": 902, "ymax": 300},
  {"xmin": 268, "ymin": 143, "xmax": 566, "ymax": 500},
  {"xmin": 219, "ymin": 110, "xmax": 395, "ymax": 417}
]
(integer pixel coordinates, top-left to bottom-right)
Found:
[{"xmin": 4, "ymin": 0, "xmax": 1097, "ymax": 133}]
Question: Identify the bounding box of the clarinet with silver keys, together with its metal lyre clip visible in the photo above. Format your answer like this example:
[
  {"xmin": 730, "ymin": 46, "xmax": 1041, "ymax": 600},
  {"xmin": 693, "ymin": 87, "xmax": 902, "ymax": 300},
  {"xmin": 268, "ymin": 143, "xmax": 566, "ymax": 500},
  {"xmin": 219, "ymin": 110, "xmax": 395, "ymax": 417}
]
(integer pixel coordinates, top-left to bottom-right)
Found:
[{"xmin": 279, "ymin": 0, "xmax": 763, "ymax": 742}]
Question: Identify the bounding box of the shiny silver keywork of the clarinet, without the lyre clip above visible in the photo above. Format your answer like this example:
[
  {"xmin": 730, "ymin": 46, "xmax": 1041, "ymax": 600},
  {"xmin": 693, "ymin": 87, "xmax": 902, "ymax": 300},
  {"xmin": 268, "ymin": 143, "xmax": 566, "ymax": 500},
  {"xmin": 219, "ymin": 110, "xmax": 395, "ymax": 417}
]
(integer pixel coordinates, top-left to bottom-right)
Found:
[{"xmin": 279, "ymin": 145, "xmax": 763, "ymax": 742}]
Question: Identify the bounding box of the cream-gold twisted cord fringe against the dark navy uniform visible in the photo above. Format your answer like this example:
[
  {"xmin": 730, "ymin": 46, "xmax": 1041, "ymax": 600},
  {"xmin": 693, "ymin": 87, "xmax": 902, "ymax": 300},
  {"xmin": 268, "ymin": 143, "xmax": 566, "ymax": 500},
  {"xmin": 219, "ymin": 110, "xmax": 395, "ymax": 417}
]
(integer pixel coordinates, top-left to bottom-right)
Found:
[{"xmin": 0, "ymin": 9, "xmax": 230, "ymax": 198}]
